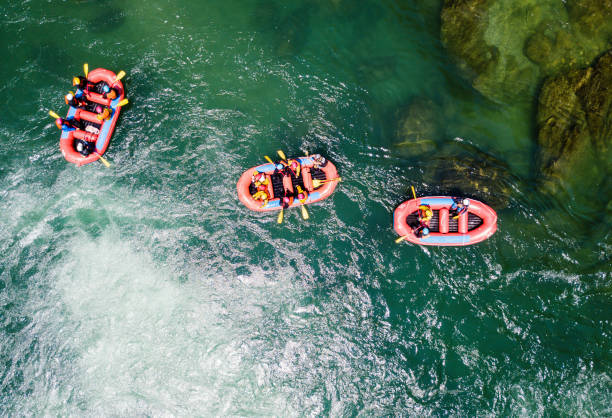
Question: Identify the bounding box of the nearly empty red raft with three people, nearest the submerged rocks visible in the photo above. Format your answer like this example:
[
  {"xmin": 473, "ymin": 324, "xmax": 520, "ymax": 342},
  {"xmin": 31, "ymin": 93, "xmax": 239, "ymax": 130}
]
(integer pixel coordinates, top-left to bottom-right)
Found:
[{"xmin": 393, "ymin": 196, "xmax": 497, "ymax": 246}]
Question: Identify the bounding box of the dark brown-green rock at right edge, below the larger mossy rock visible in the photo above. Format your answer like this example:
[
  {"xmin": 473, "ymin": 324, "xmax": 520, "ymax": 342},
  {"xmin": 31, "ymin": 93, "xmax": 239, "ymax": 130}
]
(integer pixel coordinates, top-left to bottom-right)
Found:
[{"xmin": 537, "ymin": 51, "xmax": 612, "ymax": 191}]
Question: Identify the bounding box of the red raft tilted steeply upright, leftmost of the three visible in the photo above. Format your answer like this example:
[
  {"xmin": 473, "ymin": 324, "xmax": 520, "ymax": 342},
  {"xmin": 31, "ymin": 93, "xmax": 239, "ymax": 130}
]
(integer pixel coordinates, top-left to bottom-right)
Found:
[{"xmin": 60, "ymin": 68, "xmax": 125, "ymax": 166}]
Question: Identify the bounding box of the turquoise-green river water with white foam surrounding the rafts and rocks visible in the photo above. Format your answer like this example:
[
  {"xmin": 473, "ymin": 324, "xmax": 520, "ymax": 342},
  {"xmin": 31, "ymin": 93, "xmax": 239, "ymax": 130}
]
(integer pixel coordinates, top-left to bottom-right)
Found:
[{"xmin": 0, "ymin": 0, "xmax": 612, "ymax": 416}]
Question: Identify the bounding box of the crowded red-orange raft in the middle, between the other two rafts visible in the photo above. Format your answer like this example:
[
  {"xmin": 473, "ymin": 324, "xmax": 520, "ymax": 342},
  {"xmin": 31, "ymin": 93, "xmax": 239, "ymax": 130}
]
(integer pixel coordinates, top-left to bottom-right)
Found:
[{"xmin": 237, "ymin": 156, "xmax": 338, "ymax": 212}]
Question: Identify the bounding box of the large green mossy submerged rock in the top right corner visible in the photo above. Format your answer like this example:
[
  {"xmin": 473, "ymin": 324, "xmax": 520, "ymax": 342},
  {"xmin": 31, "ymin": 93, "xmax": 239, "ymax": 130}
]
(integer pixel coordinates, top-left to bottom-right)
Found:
[{"xmin": 441, "ymin": 0, "xmax": 612, "ymax": 101}]
